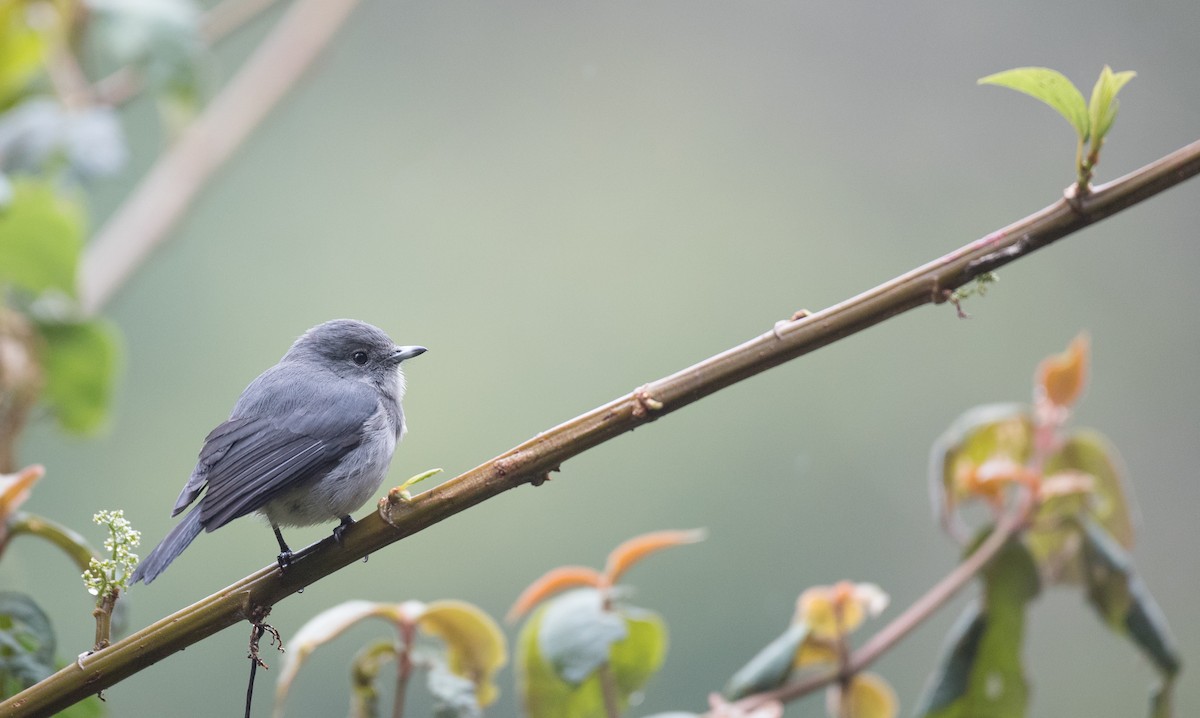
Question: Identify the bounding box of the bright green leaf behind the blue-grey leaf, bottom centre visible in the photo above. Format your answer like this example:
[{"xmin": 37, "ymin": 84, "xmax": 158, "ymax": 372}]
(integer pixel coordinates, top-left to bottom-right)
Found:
[{"xmin": 516, "ymin": 590, "xmax": 666, "ymax": 718}]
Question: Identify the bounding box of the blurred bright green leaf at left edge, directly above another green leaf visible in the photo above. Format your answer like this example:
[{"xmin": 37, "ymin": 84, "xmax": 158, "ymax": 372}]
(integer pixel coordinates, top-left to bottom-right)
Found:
[{"xmin": 0, "ymin": 179, "xmax": 84, "ymax": 297}]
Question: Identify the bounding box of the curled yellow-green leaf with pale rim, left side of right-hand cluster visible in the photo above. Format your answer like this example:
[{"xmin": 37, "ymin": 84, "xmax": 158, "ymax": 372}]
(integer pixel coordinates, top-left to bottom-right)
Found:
[{"xmin": 929, "ymin": 403, "xmax": 1033, "ymax": 535}]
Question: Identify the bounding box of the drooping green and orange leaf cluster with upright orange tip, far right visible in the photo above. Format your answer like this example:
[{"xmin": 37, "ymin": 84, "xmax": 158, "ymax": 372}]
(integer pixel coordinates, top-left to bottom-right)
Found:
[{"xmin": 918, "ymin": 335, "xmax": 1180, "ymax": 718}]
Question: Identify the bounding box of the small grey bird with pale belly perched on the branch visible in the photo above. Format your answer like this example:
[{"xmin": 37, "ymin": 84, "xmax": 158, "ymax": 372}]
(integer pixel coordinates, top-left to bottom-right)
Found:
[{"xmin": 132, "ymin": 319, "xmax": 425, "ymax": 584}]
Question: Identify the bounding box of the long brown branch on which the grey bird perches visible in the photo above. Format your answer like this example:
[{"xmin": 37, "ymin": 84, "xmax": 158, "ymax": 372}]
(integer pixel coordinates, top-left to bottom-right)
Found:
[{"xmin": 0, "ymin": 140, "xmax": 1200, "ymax": 718}]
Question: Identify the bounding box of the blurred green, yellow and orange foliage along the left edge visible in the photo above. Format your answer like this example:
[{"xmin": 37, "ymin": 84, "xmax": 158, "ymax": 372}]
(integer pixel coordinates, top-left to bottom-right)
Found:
[{"xmin": 0, "ymin": 0, "xmax": 204, "ymax": 716}]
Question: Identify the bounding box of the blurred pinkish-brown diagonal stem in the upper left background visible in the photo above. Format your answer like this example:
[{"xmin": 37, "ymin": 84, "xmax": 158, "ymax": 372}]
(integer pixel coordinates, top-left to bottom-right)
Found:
[{"xmin": 79, "ymin": 0, "xmax": 358, "ymax": 315}]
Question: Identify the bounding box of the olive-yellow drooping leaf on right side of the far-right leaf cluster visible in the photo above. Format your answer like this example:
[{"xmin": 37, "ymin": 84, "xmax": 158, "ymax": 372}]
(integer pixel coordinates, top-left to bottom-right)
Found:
[{"xmin": 1026, "ymin": 430, "xmax": 1133, "ymax": 584}]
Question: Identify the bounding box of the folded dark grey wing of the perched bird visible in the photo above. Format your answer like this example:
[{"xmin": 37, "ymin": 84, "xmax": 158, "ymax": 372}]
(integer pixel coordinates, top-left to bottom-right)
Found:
[{"xmin": 192, "ymin": 372, "xmax": 379, "ymax": 531}]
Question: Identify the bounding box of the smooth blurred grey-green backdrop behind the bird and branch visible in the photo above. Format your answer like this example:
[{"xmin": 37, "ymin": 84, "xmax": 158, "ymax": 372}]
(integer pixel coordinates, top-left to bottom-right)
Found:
[{"xmin": 0, "ymin": 0, "xmax": 1200, "ymax": 717}]
